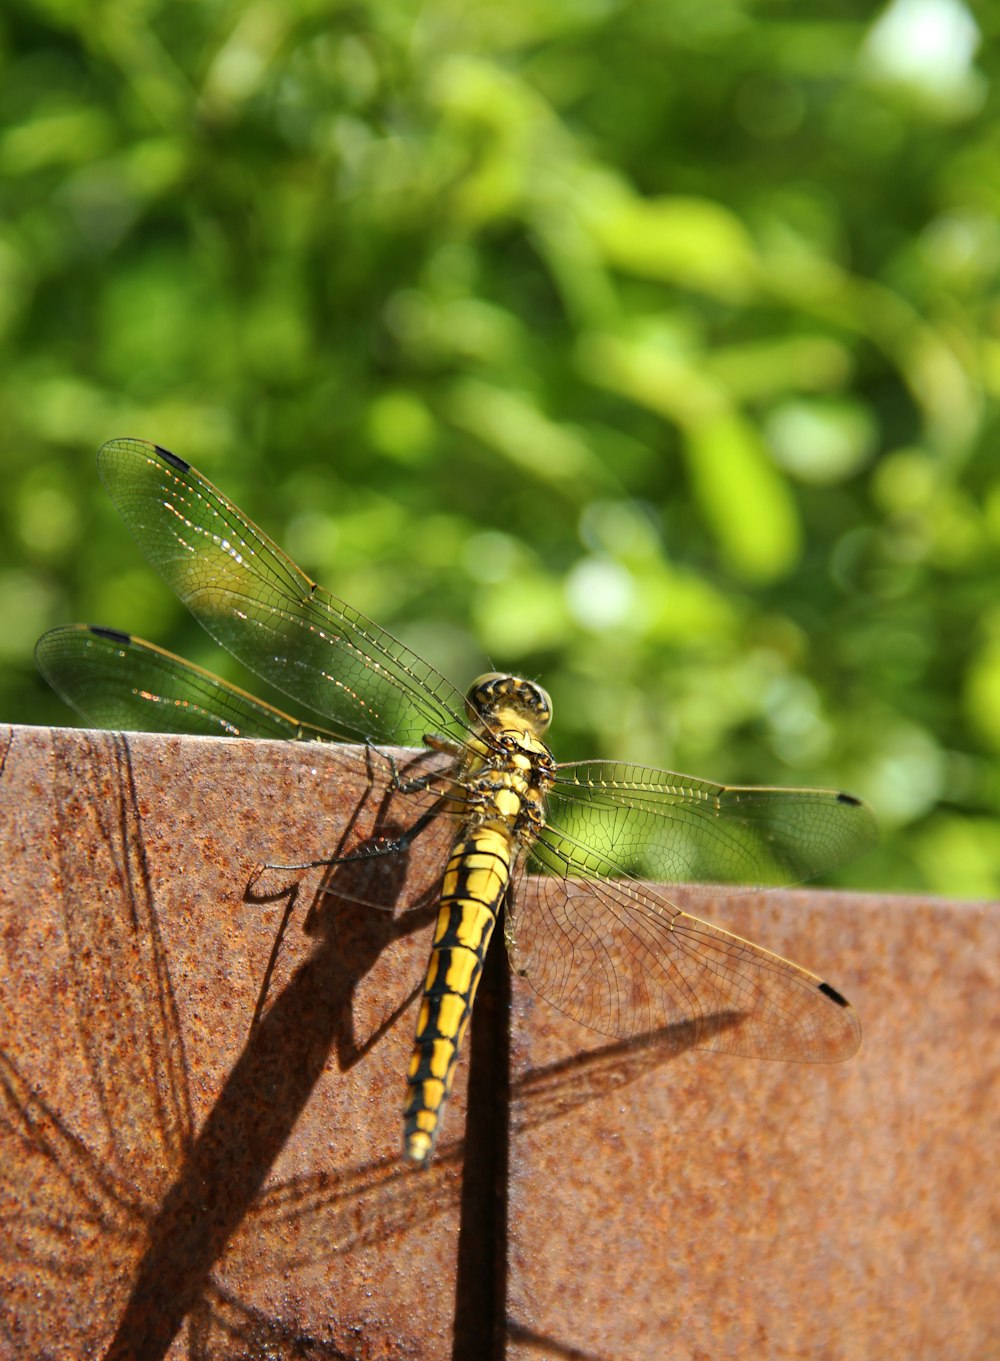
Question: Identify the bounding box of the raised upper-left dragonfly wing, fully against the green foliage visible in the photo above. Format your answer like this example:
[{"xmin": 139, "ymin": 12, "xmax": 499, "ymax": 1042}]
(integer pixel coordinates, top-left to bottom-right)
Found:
[{"xmin": 98, "ymin": 440, "xmax": 467, "ymax": 746}]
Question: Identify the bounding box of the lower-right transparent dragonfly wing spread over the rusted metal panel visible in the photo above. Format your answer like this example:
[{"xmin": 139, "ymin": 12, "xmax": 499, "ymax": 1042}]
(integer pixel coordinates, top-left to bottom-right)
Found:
[{"xmin": 507, "ymin": 834, "xmax": 861, "ymax": 1063}]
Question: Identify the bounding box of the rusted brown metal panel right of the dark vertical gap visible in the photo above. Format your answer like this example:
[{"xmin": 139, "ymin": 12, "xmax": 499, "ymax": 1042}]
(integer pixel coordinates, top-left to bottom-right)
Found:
[{"xmin": 507, "ymin": 890, "xmax": 1000, "ymax": 1361}]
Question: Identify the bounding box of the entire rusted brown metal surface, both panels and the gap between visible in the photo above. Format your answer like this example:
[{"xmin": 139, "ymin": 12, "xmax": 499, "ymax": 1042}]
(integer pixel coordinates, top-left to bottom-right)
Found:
[{"xmin": 0, "ymin": 728, "xmax": 1000, "ymax": 1361}]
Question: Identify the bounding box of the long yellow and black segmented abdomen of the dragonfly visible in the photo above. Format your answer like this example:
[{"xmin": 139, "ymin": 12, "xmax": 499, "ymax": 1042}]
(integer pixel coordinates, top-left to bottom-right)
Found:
[{"xmin": 403, "ymin": 827, "xmax": 513, "ymax": 1162}]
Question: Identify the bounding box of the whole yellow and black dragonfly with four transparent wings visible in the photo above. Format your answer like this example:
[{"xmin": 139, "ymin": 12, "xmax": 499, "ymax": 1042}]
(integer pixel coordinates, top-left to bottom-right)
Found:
[{"xmin": 35, "ymin": 438, "xmax": 876, "ymax": 1165}]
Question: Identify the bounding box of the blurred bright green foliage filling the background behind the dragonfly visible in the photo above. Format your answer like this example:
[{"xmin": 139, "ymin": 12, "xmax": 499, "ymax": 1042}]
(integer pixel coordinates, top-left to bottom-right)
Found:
[{"xmin": 0, "ymin": 0, "xmax": 1000, "ymax": 896}]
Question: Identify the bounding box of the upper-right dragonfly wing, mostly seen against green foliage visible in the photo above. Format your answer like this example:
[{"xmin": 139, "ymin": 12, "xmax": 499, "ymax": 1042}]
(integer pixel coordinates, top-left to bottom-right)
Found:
[{"xmin": 547, "ymin": 761, "xmax": 878, "ymax": 887}]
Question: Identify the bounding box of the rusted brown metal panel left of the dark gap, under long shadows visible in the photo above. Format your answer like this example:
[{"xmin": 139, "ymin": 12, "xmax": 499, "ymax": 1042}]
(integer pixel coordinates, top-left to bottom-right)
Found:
[{"xmin": 0, "ymin": 728, "xmax": 464, "ymax": 1361}]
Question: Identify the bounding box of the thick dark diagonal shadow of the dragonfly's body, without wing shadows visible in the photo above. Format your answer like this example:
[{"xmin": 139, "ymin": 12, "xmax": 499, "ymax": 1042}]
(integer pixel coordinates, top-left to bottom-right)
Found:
[{"xmin": 107, "ymin": 745, "xmax": 443, "ymax": 1358}]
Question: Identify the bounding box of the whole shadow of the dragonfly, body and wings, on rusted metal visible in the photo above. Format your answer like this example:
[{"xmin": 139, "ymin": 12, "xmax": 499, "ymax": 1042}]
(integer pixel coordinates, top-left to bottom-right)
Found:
[{"xmin": 0, "ymin": 735, "xmax": 733, "ymax": 1358}]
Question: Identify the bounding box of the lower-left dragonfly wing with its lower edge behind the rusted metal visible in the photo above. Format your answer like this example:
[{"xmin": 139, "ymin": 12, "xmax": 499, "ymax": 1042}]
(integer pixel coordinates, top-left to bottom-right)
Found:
[{"xmin": 35, "ymin": 623, "xmax": 335, "ymax": 742}]
